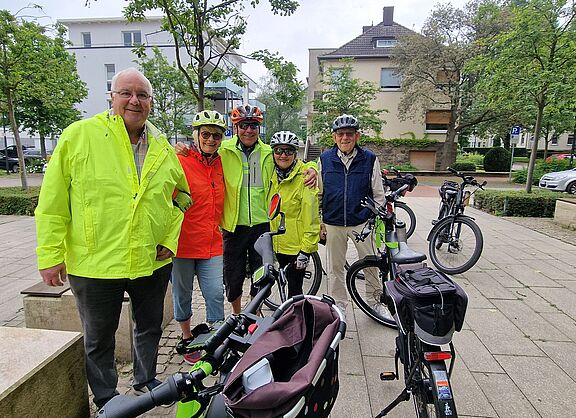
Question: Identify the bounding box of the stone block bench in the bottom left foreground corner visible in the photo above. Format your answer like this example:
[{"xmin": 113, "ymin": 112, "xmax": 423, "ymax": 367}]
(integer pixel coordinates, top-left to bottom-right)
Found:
[{"xmin": 0, "ymin": 327, "xmax": 90, "ymax": 418}]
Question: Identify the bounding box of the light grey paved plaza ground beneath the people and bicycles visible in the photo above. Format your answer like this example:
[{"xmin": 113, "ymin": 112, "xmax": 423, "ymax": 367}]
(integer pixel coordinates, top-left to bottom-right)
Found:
[{"xmin": 0, "ymin": 192, "xmax": 576, "ymax": 418}]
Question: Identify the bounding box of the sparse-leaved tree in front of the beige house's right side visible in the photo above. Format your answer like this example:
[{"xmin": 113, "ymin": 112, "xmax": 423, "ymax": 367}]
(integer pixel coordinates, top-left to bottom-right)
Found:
[{"xmin": 392, "ymin": 1, "xmax": 501, "ymax": 168}]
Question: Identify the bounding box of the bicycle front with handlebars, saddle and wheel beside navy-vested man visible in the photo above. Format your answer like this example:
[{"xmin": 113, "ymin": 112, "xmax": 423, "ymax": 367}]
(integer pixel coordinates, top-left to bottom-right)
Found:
[{"xmin": 346, "ymin": 184, "xmax": 426, "ymax": 328}]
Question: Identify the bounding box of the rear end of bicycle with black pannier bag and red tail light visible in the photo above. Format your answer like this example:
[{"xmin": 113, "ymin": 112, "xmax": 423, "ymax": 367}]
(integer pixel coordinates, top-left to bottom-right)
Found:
[{"xmin": 376, "ymin": 268, "xmax": 468, "ymax": 418}]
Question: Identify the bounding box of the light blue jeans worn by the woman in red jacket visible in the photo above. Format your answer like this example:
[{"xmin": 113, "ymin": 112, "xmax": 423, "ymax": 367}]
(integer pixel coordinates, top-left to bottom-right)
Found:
[{"xmin": 171, "ymin": 255, "xmax": 224, "ymax": 322}]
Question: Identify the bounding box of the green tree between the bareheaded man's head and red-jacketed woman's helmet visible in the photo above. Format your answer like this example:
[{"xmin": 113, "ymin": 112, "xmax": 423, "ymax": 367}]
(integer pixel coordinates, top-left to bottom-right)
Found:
[{"xmin": 138, "ymin": 47, "xmax": 196, "ymax": 143}]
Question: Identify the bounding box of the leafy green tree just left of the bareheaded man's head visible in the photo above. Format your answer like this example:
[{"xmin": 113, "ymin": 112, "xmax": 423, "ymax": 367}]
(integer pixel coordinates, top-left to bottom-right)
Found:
[{"xmin": 17, "ymin": 25, "xmax": 88, "ymax": 158}]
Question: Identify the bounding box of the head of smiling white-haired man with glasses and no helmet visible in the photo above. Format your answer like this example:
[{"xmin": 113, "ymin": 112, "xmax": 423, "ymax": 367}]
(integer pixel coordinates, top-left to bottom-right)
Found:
[{"xmin": 111, "ymin": 73, "xmax": 152, "ymax": 131}]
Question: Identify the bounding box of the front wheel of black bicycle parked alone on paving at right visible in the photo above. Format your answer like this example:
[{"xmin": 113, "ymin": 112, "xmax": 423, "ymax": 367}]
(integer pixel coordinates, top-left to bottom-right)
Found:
[{"xmin": 428, "ymin": 217, "xmax": 484, "ymax": 274}]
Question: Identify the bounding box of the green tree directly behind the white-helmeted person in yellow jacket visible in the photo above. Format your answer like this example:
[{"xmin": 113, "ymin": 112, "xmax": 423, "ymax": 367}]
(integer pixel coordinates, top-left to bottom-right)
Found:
[{"xmin": 253, "ymin": 51, "xmax": 306, "ymax": 140}]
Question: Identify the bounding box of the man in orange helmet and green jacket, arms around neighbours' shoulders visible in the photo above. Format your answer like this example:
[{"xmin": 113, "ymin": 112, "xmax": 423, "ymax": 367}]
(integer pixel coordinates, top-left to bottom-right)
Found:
[{"xmin": 176, "ymin": 104, "xmax": 317, "ymax": 313}]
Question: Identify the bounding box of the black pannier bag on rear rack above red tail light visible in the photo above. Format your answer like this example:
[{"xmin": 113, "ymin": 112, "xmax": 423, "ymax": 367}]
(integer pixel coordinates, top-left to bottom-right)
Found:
[{"xmin": 386, "ymin": 267, "xmax": 468, "ymax": 345}]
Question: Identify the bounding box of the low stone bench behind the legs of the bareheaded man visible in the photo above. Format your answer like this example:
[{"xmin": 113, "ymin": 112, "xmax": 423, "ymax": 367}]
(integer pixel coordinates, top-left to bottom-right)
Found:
[{"xmin": 21, "ymin": 282, "xmax": 174, "ymax": 362}]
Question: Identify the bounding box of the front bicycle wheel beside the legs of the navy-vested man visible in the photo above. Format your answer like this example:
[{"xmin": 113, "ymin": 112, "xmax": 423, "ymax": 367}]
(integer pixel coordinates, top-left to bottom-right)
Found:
[{"xmin": 346, "ymin": 256, "xmax": 396, "ymax": 328}]
